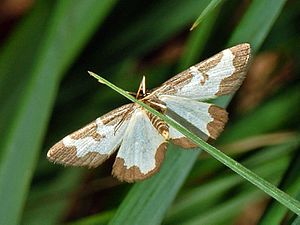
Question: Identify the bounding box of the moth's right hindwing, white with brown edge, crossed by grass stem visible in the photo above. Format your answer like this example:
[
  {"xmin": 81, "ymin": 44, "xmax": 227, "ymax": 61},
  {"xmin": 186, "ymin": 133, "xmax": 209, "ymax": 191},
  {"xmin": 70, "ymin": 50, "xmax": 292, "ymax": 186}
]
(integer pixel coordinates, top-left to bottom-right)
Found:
[{"xmin": 160, "ymin": 95, "xmax": 228, "ymax": 148}]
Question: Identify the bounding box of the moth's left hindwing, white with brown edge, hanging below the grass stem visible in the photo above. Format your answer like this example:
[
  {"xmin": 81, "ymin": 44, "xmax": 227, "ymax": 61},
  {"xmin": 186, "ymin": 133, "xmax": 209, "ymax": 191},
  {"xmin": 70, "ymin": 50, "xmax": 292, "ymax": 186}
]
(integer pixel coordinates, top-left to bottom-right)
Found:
[{"xmin": 112, "ymin": 109, "xmax": 167, "ymax": 182}]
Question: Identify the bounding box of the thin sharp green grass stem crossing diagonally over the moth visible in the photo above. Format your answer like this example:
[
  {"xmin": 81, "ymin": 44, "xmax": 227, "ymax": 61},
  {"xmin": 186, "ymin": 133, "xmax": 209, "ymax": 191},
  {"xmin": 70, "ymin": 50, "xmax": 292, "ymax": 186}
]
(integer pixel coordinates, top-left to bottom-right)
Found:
[{"xmin": 89, "ymin": 72, "xmax": 300, "ymax": 215}]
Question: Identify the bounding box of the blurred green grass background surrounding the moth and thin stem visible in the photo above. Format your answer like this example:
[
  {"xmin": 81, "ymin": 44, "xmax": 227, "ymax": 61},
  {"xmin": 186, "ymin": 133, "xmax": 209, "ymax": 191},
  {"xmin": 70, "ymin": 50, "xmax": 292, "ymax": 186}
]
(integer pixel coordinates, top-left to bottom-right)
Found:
[{"xmin": 0, "ymin": 0, "xmax": 300, "ymax": 225}]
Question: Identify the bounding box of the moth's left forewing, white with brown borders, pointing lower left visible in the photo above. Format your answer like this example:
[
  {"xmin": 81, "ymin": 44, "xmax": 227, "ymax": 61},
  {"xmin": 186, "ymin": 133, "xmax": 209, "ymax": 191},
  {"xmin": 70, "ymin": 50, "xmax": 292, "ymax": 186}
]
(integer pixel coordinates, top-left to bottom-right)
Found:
[{"xmin": 47, "ymin": 104, "xmax": 135, "ymax": 167}]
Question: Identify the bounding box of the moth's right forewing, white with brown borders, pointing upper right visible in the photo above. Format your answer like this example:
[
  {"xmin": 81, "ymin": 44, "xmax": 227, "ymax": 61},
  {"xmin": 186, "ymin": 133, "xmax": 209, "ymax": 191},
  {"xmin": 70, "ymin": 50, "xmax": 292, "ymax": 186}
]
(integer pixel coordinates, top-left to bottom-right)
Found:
[{"xmin": 155, "ymin": 43, "xmax": 250, "ymax": 101}]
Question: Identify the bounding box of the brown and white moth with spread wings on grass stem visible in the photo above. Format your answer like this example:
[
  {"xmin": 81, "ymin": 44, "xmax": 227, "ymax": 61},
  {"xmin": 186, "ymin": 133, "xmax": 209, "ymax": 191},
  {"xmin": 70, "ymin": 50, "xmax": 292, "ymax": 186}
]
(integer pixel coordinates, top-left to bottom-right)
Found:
[{"xmin": 47, "ymin": 43, "xmax": 250, "ymax": 182}]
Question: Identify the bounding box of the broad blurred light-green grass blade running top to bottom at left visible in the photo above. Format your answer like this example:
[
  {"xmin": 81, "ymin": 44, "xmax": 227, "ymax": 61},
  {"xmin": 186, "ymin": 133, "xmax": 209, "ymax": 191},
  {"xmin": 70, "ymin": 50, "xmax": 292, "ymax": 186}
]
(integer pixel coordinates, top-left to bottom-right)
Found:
[{"xmin": 0, "ymin": 0, "xmax": 115, "ymax": 225}]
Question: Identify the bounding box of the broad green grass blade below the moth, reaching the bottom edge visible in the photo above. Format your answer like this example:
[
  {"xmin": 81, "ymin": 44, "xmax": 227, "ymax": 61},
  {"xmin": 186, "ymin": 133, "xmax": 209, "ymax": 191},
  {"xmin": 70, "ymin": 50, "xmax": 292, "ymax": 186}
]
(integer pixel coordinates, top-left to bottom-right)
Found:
[{"xmin": 109, "ymin": 147, "xmax": 199, "ymax": 225}]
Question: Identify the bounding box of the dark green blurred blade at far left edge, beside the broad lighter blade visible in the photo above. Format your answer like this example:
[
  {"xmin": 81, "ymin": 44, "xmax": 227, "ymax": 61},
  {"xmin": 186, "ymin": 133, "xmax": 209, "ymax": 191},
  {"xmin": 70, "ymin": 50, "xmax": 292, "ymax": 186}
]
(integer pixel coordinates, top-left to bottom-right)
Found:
[{"xmin": 0, "ymin": 1, "xmax": 52, "ymax": 160}]
